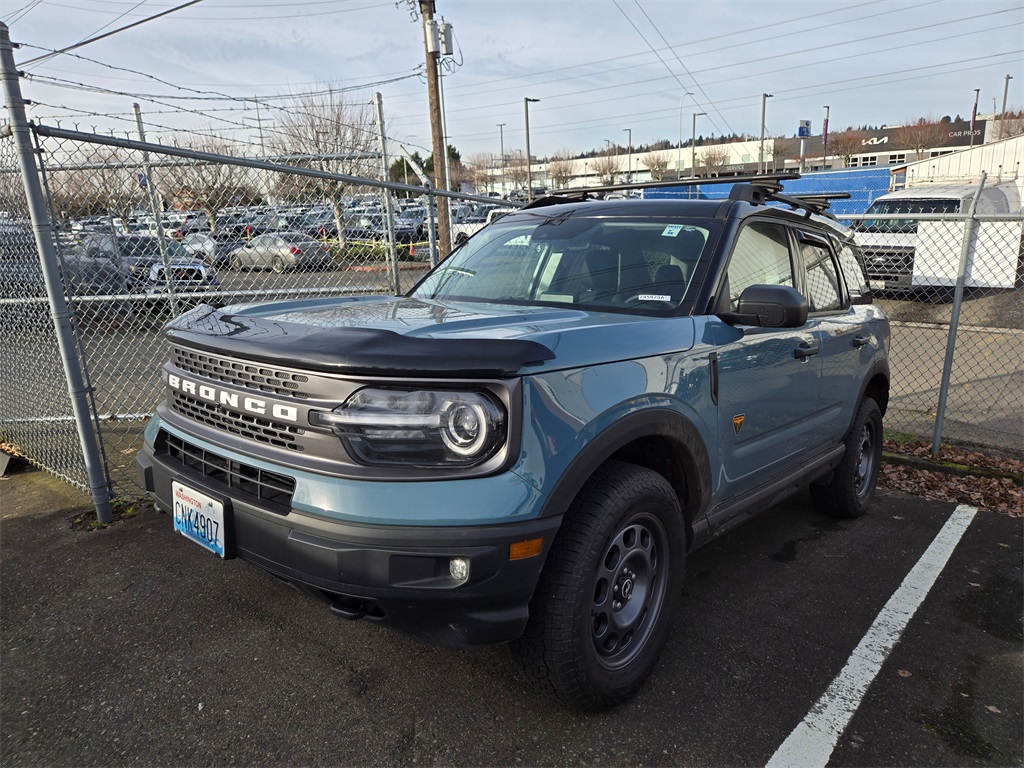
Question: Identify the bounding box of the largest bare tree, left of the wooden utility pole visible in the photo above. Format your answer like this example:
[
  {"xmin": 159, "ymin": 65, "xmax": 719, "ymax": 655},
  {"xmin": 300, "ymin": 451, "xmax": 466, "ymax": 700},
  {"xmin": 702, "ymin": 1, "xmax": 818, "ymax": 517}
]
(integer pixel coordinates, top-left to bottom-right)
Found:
[{"xmin": 276, "ymin": 86, "xmax": 378, "ymax": 232}]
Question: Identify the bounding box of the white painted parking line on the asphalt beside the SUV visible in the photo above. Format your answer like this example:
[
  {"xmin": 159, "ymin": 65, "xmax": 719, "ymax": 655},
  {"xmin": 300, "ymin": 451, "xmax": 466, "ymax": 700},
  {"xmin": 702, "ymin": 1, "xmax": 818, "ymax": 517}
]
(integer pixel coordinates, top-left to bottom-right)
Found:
[{"xmin": 767, "ymin": 505, "xmax": 978, "ymax": 768}]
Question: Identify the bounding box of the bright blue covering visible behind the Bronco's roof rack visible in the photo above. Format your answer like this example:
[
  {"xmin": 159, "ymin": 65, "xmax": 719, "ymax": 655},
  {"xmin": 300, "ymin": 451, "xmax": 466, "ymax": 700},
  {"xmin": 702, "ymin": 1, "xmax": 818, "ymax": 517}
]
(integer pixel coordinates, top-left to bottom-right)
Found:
[{"xmin": 644, "ymin": 167, "xmax": 890, "ymax": 218}]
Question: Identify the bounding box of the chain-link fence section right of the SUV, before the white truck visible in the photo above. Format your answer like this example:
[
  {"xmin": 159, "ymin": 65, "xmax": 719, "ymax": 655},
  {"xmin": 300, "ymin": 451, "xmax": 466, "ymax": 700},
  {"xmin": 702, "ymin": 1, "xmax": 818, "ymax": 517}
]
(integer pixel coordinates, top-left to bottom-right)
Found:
[{"xmin": 847, "ymin": 207, "xmax": 1024, "ymax": 453}]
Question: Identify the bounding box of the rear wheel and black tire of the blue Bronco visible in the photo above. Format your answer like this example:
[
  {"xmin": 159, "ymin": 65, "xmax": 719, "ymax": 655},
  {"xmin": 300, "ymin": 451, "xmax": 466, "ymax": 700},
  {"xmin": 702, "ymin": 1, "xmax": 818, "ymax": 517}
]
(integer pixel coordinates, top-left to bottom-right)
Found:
[{"xmin": 811, "ymin": 397, "xmax": 882, "ymax": 518}]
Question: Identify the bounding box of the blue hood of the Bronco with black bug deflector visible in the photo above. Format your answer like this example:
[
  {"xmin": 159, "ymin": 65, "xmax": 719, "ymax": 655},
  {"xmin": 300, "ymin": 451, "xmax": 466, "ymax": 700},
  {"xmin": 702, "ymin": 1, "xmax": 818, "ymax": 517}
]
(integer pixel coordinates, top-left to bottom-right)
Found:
[{"xmin": 165, "ymin": 296, "xmax": 694, "ymax": 377}]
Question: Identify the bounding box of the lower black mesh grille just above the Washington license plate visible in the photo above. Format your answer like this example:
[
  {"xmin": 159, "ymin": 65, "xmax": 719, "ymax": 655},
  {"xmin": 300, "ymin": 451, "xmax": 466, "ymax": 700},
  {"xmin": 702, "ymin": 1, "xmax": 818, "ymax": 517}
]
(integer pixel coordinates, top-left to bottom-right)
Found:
[{"xmin": 157, "ymin": 430, "xmax": 295, "ymax": 514}]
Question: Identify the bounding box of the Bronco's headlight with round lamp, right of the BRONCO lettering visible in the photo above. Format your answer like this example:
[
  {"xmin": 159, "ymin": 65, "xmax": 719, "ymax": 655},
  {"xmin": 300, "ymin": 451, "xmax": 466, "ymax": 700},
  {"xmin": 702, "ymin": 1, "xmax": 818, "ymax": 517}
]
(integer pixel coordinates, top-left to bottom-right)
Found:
[{"xmin": 309, "ymin": 389, "xmax": 507, "ymax": 467}]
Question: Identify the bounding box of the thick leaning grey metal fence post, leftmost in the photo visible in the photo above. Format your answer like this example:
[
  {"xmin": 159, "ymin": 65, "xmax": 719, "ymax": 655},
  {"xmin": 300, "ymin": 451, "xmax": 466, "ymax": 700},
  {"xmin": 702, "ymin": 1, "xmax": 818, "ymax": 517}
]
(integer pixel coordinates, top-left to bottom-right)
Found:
[{"xmin": 0, "ymin": 23, "xmax": 114, "ymax": 523}]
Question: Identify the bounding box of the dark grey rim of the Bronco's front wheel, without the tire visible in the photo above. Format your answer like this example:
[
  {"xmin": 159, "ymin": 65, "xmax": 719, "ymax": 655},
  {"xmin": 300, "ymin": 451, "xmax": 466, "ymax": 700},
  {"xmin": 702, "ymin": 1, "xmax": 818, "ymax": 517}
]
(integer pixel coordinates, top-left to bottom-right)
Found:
[{"xmin": 591, "ymin": 514, "xmax": 669, "ymax": 669}]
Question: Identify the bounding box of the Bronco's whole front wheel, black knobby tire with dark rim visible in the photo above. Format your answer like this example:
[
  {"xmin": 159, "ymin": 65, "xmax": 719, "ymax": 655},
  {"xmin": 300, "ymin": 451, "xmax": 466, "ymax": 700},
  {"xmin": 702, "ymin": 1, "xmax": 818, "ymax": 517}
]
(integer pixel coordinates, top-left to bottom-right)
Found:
[{"xmin": 512, "ymin": 462, "xmax": 686, "ymax": 712}]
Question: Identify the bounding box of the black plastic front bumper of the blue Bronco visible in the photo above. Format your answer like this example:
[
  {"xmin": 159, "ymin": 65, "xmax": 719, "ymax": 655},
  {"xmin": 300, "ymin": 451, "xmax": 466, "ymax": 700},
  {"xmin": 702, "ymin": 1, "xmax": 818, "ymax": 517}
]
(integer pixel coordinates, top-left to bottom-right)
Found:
[{"xmin": 138, "ymin": 428, "xmax": 560, "ymax": 648}]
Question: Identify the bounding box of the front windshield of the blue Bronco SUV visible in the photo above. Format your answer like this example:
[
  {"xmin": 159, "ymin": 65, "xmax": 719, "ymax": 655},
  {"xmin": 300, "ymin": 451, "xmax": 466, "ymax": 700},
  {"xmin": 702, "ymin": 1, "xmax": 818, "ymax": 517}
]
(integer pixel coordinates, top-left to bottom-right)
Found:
[{"xmin": 412, "ymin": 211, "xmax": 717, "ymax": 313}]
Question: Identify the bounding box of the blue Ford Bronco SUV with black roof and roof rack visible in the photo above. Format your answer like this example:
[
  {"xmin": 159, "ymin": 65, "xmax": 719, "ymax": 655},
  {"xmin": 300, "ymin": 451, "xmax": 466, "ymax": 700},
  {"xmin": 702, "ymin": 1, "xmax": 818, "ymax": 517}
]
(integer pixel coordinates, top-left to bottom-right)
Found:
[{"xmin": 139, "ymin": 177, "xmax": 889, "ymax": 711}]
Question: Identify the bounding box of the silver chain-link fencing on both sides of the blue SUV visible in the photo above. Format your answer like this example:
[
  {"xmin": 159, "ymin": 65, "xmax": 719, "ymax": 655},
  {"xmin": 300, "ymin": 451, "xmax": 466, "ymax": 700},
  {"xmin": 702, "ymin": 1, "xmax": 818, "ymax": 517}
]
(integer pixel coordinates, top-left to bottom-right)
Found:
[{"xmin": 0, "ymin": 120, "xmax": 1024, "ymax": 507}]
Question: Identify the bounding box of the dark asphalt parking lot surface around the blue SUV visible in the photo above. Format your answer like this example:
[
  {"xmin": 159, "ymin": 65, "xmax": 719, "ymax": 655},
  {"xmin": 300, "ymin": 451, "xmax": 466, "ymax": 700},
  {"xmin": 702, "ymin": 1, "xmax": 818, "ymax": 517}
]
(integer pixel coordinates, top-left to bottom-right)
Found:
[{"xmin": 0, "ymin": 470, "xmax": 1024, "ymax": 766}]
